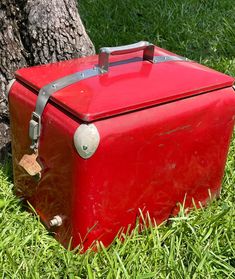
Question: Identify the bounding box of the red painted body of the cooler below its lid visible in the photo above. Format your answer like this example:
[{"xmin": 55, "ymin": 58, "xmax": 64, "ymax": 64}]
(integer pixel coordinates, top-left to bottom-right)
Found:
[{"xmin": 10, "ymin": 82, "xmax": 235, "ymax": 248}]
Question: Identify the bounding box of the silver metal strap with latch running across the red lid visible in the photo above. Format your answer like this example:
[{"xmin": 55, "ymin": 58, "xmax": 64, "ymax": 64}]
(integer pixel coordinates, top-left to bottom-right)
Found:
[{"xmin": 29, "ymin": 55, "xmax": 190, "ymax": 150}]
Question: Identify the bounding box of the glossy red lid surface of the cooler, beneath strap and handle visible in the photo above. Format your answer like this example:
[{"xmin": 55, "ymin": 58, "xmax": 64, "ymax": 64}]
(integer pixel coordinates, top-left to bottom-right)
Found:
[{"xmin": 16, "ymin": 47, "xmax": 234, "ymax": 121}]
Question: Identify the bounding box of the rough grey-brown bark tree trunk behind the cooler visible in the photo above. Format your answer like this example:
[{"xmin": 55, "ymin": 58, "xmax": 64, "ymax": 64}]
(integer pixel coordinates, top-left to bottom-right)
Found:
[{"xmin": 0, "ymin": 0, "xmax": 94, "ymax": 161}]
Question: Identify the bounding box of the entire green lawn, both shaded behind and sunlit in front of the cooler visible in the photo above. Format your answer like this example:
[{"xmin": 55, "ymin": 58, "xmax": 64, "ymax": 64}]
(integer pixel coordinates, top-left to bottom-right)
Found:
[{"xmin": 0, "ymin": 0, "xmax": 235, "ymax": 279}]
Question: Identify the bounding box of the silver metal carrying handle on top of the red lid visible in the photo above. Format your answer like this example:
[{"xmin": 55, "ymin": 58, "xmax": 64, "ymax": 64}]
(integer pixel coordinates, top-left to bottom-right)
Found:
[{"xmin": 98, "ymin": 41, "xmax": 154, "ymax": 73}]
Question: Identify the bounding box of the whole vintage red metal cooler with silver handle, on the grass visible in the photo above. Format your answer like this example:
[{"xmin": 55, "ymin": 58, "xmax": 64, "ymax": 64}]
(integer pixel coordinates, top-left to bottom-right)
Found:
[{"xmin": 9, "ymin": 42, "xmax": 235, "ymax": 250}]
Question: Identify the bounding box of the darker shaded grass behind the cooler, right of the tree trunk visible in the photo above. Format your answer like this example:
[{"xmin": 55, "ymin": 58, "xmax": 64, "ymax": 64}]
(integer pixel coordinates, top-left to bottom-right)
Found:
[{"xmin": 79, "ymin": 0, "xmax": 235, "ymax": 75}]
